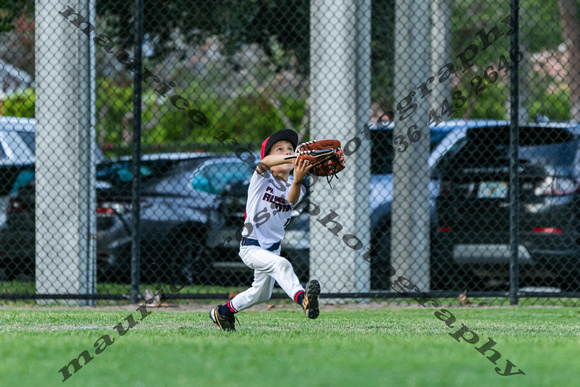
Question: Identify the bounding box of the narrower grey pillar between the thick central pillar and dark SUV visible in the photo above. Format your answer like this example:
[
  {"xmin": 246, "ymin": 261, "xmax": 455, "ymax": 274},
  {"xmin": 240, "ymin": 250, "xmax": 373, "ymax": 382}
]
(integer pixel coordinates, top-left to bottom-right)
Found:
[{"xmin": 391, "ymin": 0, "xmax": 431, "ymax": 292}]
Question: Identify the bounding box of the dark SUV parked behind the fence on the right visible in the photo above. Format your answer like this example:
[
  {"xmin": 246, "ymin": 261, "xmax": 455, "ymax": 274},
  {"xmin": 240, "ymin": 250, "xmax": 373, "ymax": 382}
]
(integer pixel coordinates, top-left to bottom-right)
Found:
[{"xmin": 432, "ymin": 123, "xmax": 580, "ymax": 290}]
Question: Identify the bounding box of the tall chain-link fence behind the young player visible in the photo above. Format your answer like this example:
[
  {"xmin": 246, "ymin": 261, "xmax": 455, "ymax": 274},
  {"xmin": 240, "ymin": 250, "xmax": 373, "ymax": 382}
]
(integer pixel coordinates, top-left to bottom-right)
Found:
[{"xmin": 0, "ymin": 0, "xmax": 580, "ymax": 305}]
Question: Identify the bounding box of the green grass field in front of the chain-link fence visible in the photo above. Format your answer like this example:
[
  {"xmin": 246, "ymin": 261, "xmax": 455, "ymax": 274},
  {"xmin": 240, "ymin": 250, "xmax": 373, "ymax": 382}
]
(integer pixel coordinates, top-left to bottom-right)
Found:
[{"xmin": 0, "ymin": 306, "xmax": 580, "ymax": 387}]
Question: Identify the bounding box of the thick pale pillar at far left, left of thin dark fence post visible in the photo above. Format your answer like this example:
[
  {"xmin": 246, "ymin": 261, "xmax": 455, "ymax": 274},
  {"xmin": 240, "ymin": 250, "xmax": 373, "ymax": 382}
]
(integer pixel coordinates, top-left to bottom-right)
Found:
[{"xmin": 35, "ymin": 0, "xmax": 97, "ymax": 305}]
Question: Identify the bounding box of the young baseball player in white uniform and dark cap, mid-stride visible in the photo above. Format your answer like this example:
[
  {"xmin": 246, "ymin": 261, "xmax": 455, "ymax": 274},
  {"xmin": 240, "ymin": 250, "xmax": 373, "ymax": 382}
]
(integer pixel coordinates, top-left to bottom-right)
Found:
[{"xmin": 210, "ymin": 129, "xmax": 320, "ymax": 331}]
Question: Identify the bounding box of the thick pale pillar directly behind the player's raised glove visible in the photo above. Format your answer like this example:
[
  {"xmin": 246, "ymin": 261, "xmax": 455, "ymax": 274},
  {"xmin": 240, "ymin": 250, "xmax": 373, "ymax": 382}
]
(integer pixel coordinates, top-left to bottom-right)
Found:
[{"xmin": 310, "ymin": 0, "xmax": 371, "ymax": 302}]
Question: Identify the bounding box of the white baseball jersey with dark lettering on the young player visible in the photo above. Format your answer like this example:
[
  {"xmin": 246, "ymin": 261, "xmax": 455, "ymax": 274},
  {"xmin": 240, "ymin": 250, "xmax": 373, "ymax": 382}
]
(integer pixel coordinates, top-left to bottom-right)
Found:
[{"xmin": 242, "ymin": 171, "xmax": 305, "ymax": 249}]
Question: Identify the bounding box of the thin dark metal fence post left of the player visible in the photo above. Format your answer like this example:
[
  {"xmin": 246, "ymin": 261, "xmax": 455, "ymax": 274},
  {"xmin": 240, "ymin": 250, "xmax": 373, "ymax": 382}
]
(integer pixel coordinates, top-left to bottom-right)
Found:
[{"xmin": 131, "ymin": 0, "xmax": 143, "ymax": 304}]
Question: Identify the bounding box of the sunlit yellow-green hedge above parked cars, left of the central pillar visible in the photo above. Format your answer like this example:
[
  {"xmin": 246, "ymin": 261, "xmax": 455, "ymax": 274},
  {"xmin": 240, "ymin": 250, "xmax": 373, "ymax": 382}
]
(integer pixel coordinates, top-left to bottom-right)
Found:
[{"xmin": 2, "ymin": 78, "xmax": 306, "ymax": 155}]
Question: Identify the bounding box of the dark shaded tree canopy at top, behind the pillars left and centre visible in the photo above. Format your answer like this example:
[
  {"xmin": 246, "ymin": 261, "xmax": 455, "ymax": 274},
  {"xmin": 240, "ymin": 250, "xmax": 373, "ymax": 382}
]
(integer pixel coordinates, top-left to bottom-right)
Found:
[{"xmin": 3, "ymin": 0, "xmax": 394, "ymax": 146}]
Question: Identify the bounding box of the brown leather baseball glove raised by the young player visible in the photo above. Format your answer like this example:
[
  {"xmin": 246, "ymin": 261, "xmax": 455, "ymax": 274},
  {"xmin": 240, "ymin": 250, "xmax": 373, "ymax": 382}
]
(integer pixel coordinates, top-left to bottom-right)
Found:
[{"xmin": 296, "ymin": 140, "xmax": 345, "ymax": 184}]
